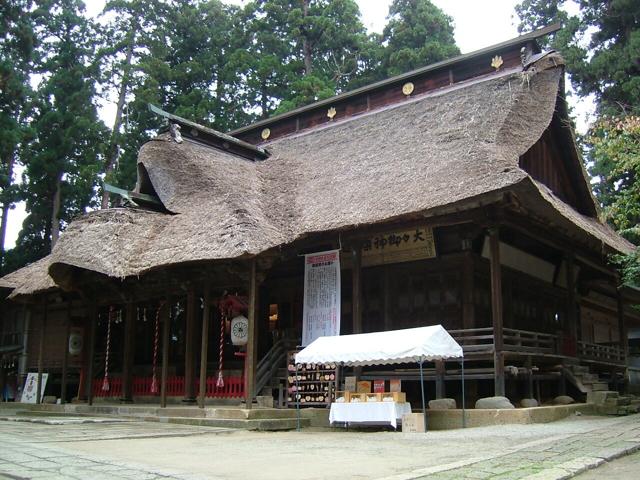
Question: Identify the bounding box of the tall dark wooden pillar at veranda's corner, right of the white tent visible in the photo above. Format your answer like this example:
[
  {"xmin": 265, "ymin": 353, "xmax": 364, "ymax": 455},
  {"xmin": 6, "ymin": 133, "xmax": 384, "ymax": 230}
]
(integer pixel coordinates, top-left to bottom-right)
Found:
[{"xmin": 489, "ymin": 228, "xmax": 505, "ymax": 397}]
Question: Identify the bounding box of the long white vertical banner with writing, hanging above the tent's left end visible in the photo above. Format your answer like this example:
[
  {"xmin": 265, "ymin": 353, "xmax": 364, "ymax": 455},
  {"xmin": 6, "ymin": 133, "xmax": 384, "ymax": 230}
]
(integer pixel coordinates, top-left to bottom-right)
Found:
[{"xmin": 302, "ymin": 250, "xmax": 340, "ymax": 347}]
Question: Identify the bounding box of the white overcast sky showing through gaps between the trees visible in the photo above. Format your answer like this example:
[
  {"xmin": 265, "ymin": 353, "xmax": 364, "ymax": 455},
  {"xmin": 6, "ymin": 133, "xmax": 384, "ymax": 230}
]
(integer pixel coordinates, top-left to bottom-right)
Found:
[{"xmin": 6, "ymin": 0, "xmax": 593, "ymax": 248}]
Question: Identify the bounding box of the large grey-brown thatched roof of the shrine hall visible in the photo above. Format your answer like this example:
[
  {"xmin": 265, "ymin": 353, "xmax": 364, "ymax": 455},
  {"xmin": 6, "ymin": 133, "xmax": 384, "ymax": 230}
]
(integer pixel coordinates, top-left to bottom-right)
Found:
[{"xmin": 3, "ymin": 52, "xmax": 631, "ymax": 294}]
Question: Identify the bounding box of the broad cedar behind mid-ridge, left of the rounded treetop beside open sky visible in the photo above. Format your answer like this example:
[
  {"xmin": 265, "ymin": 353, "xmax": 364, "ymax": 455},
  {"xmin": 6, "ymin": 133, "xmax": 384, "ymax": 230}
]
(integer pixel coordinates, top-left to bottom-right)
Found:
[{"xmin": 244, "ymin": 0, "xmax": 372, "ymax": 117}]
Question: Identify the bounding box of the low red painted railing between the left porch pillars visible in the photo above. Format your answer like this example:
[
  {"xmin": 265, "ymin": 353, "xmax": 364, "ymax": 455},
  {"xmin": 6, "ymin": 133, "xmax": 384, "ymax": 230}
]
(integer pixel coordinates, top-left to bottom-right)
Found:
[{"xmin": 93, "ymin": 376, "xmax": 244, "ymax": 398}]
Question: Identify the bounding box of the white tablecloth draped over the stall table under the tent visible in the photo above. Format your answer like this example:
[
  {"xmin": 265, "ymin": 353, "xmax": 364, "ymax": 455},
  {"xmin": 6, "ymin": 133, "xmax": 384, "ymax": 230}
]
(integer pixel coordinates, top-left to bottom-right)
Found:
[{"xmin": 329, "ymin": 402, "xmax": 411, "ymax": 428}]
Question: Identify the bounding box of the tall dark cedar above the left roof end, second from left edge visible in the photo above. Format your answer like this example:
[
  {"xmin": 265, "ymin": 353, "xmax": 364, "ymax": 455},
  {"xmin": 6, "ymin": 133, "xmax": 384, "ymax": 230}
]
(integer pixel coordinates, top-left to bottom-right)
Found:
[{"xmin": 16, "ymin": 0, "xmax": 106, "ymax": 260}]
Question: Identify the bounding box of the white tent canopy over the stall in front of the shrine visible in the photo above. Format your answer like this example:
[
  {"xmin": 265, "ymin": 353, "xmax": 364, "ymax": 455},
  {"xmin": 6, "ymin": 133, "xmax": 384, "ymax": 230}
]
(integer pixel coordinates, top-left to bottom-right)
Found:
[{"xmin": 295, "ymin": 325, "xmax": 463, "ymax": 367}]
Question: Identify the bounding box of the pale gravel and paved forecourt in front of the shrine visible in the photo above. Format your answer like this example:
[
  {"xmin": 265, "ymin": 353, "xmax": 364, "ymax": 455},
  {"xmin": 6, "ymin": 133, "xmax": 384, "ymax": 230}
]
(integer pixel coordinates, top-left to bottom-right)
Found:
[{"xmin": 0, "ymin": 415, "xmax": 640, "ymax": 480}]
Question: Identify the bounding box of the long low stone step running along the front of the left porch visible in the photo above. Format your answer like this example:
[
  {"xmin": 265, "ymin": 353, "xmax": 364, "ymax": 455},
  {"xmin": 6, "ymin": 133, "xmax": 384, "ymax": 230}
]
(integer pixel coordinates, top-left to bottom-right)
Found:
[{"xmin": 1, "ymin": 404, "xmax": 311, "ymax": 431}]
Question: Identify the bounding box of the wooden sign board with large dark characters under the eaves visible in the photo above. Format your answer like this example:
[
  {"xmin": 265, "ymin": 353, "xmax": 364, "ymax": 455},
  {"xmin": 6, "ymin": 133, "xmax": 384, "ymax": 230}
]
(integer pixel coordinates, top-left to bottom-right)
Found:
[{"xmin": 362, "ymin": 227, "xmax": 436, "ymax": 267}]
